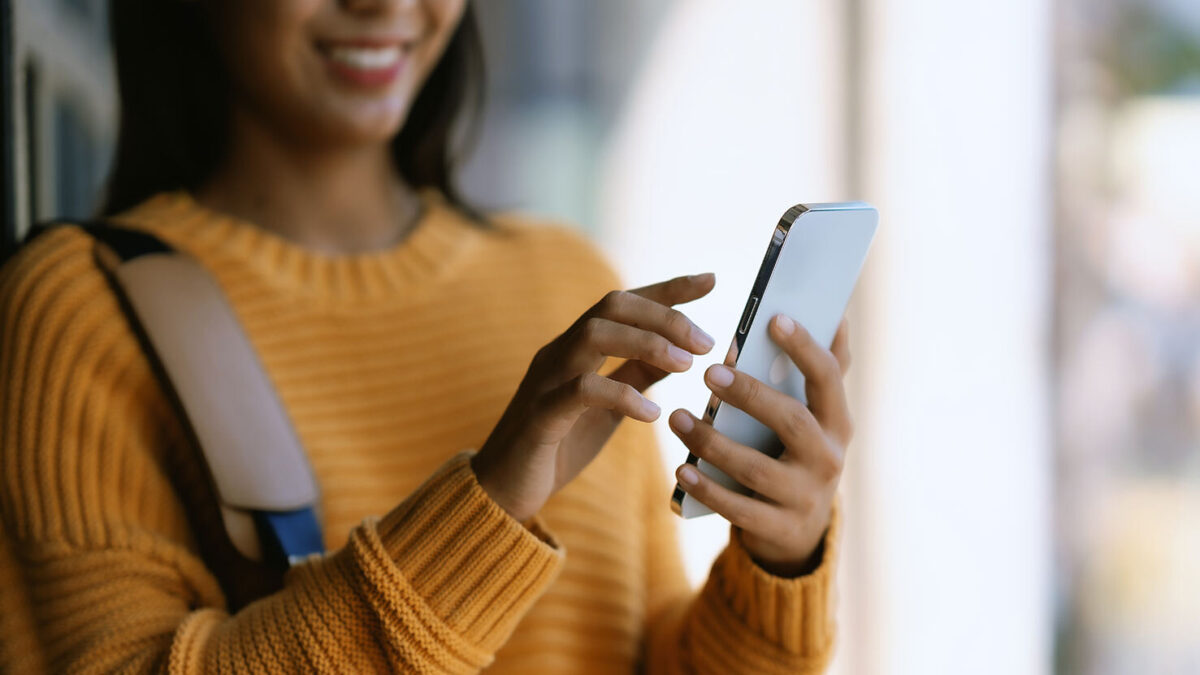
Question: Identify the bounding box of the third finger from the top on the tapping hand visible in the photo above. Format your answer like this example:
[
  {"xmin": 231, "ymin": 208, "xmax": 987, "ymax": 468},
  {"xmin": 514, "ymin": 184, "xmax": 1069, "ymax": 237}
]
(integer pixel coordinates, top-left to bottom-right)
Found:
[{"xmin": 566, "ymin": 317, "xmax": 691, "ymax": 372}]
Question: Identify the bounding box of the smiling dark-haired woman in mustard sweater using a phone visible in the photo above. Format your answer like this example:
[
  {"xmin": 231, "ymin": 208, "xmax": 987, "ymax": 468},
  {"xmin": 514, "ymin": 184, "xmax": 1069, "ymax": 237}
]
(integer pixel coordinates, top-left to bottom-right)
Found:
[{"xmin": 0, "ymin": 0, "xmax": 850, "ymax": 674}]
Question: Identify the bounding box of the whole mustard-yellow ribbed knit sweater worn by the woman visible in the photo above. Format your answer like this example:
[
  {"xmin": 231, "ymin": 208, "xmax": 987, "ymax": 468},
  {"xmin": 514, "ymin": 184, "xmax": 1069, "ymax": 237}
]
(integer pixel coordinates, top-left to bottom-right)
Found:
[{"xmin": 0, "ymin": 192, "xmax": 836, "ymax": 675}]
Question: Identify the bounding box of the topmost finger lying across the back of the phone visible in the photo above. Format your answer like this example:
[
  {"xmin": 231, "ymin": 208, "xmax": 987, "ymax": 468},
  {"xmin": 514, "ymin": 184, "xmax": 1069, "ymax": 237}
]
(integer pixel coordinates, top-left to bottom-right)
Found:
[{"xmin": 770, "ymin": 315, "xmax": 851, "ymax": 443}]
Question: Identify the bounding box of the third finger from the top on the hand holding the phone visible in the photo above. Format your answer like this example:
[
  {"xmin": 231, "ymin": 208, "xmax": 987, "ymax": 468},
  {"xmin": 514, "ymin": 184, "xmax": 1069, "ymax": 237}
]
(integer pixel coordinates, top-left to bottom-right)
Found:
[{"xmin": 670, "ymin": 410, "xmax": 799, "ymax": 503}]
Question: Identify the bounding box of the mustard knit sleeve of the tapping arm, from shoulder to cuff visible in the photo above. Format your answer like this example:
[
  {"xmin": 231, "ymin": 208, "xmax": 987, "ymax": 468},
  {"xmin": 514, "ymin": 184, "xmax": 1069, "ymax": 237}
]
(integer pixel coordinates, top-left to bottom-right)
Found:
[{"xmin": 0, "ymin": 229, "xmax": 563, "ymax": 673}]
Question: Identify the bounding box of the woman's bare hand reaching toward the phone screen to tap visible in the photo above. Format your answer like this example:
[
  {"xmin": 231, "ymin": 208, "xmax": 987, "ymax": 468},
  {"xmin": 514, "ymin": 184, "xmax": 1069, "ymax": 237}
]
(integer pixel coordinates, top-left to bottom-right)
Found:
[{"xmin": 472, "ymin": 274, "xmax": 715, "ymax": 521}]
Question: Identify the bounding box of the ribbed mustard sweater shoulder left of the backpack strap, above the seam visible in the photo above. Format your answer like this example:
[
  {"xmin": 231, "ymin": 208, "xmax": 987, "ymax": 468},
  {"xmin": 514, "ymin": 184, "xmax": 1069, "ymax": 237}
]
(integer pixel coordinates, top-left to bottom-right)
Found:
[{"xmin": 0, "ymin": 226, "xmax": 181, "ymax": 545}]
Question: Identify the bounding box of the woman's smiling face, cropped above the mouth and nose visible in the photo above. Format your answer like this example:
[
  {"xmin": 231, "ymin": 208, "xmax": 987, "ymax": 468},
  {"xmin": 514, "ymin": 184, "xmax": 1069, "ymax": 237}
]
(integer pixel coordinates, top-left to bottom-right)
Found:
[{"xmin": 208, "ymin": 0, "xmax": 467, "ymax": 145}]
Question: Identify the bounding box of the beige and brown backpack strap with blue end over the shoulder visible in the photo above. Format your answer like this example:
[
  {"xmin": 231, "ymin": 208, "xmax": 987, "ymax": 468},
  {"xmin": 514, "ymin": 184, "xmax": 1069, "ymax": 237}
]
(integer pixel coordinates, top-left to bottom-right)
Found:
[{"xmin": 57, "ymin": 222, "xmax": 324, "ymax": 568}]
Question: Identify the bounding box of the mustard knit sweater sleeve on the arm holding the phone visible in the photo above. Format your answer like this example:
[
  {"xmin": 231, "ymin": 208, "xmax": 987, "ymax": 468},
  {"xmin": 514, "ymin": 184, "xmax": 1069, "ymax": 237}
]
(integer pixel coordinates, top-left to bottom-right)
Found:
[{"xmin": 640, "ymin": 417, "xmax": 838, "ymax": 675}]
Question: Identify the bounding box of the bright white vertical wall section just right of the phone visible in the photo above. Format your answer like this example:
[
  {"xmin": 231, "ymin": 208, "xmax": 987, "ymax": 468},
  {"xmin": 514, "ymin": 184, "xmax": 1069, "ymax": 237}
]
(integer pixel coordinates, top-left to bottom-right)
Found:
[{"xmin": 858, "ymin": 0, "xmax": 1052, "ymax": 674}]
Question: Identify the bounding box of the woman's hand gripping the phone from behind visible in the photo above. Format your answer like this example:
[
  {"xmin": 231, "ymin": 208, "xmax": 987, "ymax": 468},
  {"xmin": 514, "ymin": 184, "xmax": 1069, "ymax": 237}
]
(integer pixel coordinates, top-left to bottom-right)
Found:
[{"xmin": 671, "ymin": 315, "xmax": 853, "ymax": 577}]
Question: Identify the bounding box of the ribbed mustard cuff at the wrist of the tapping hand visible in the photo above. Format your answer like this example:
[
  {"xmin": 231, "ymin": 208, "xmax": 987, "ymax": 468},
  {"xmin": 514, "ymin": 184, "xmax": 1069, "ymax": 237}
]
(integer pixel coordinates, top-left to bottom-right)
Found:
[{"xmin": 378, "ymin": 450, "xmax": 564, "ymax": 652}]
